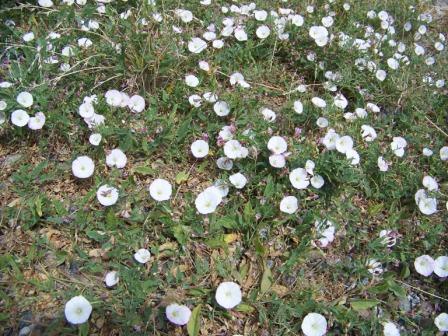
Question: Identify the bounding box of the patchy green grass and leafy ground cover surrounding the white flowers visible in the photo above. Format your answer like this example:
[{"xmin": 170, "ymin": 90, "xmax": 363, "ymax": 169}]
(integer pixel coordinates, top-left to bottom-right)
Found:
[{"xmin": 0, "ymin": 0, "xmax": 448, "ymax": 336}]
